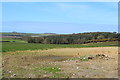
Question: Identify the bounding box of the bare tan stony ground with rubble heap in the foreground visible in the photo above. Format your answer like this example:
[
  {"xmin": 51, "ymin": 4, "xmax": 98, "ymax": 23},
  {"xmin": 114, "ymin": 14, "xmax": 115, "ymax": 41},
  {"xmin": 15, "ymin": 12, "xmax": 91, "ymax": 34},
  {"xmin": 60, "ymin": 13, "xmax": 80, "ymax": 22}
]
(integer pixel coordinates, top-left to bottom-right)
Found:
[{"xmin": 2, "ymin": 47, "xmax": 118, "ymax": 78}]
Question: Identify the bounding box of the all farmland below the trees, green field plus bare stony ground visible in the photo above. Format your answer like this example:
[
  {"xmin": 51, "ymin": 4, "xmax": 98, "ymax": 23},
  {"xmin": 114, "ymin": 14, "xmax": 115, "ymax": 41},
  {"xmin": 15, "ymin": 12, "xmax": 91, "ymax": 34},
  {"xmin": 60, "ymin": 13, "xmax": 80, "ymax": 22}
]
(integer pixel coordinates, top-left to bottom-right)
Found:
[{"xmin": 0, "ymin": 32, "xmax": 119, "ymax": 78}]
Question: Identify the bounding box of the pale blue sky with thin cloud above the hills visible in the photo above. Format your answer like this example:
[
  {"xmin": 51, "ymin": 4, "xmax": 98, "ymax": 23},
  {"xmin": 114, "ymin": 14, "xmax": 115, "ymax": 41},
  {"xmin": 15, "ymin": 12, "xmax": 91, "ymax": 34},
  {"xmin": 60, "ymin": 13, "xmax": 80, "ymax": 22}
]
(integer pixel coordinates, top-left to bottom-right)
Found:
[{"xmin": 2, "ymin": 2, "xmax": 118, "ymax": 34}]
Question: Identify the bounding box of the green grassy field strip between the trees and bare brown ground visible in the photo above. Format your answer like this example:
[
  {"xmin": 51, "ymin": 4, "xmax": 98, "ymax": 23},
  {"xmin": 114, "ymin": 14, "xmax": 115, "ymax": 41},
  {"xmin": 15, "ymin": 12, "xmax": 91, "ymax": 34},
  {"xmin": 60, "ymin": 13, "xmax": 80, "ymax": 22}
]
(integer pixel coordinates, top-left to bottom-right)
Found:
[{"xmin": 0, "ymin": 41, "xmax": 118, "ymax": 52}]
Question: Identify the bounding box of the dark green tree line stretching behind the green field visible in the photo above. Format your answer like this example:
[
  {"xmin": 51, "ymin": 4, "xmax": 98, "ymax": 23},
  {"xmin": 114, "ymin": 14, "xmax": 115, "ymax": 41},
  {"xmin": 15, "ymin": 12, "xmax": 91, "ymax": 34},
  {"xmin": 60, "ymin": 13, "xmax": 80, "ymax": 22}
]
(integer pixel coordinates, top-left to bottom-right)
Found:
[{"xmin": 24, "ymin": 32, "xmax": 120, "ymax": 44}]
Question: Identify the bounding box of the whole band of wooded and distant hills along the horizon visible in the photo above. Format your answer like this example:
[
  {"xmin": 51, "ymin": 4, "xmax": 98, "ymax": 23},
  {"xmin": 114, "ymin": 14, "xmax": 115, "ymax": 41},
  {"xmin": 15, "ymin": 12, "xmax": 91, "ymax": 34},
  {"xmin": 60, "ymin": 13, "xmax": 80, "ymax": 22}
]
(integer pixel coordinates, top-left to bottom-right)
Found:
[{"xmin": 0, "ymin": 32, "xmax": 120, "ymax": 44}]
